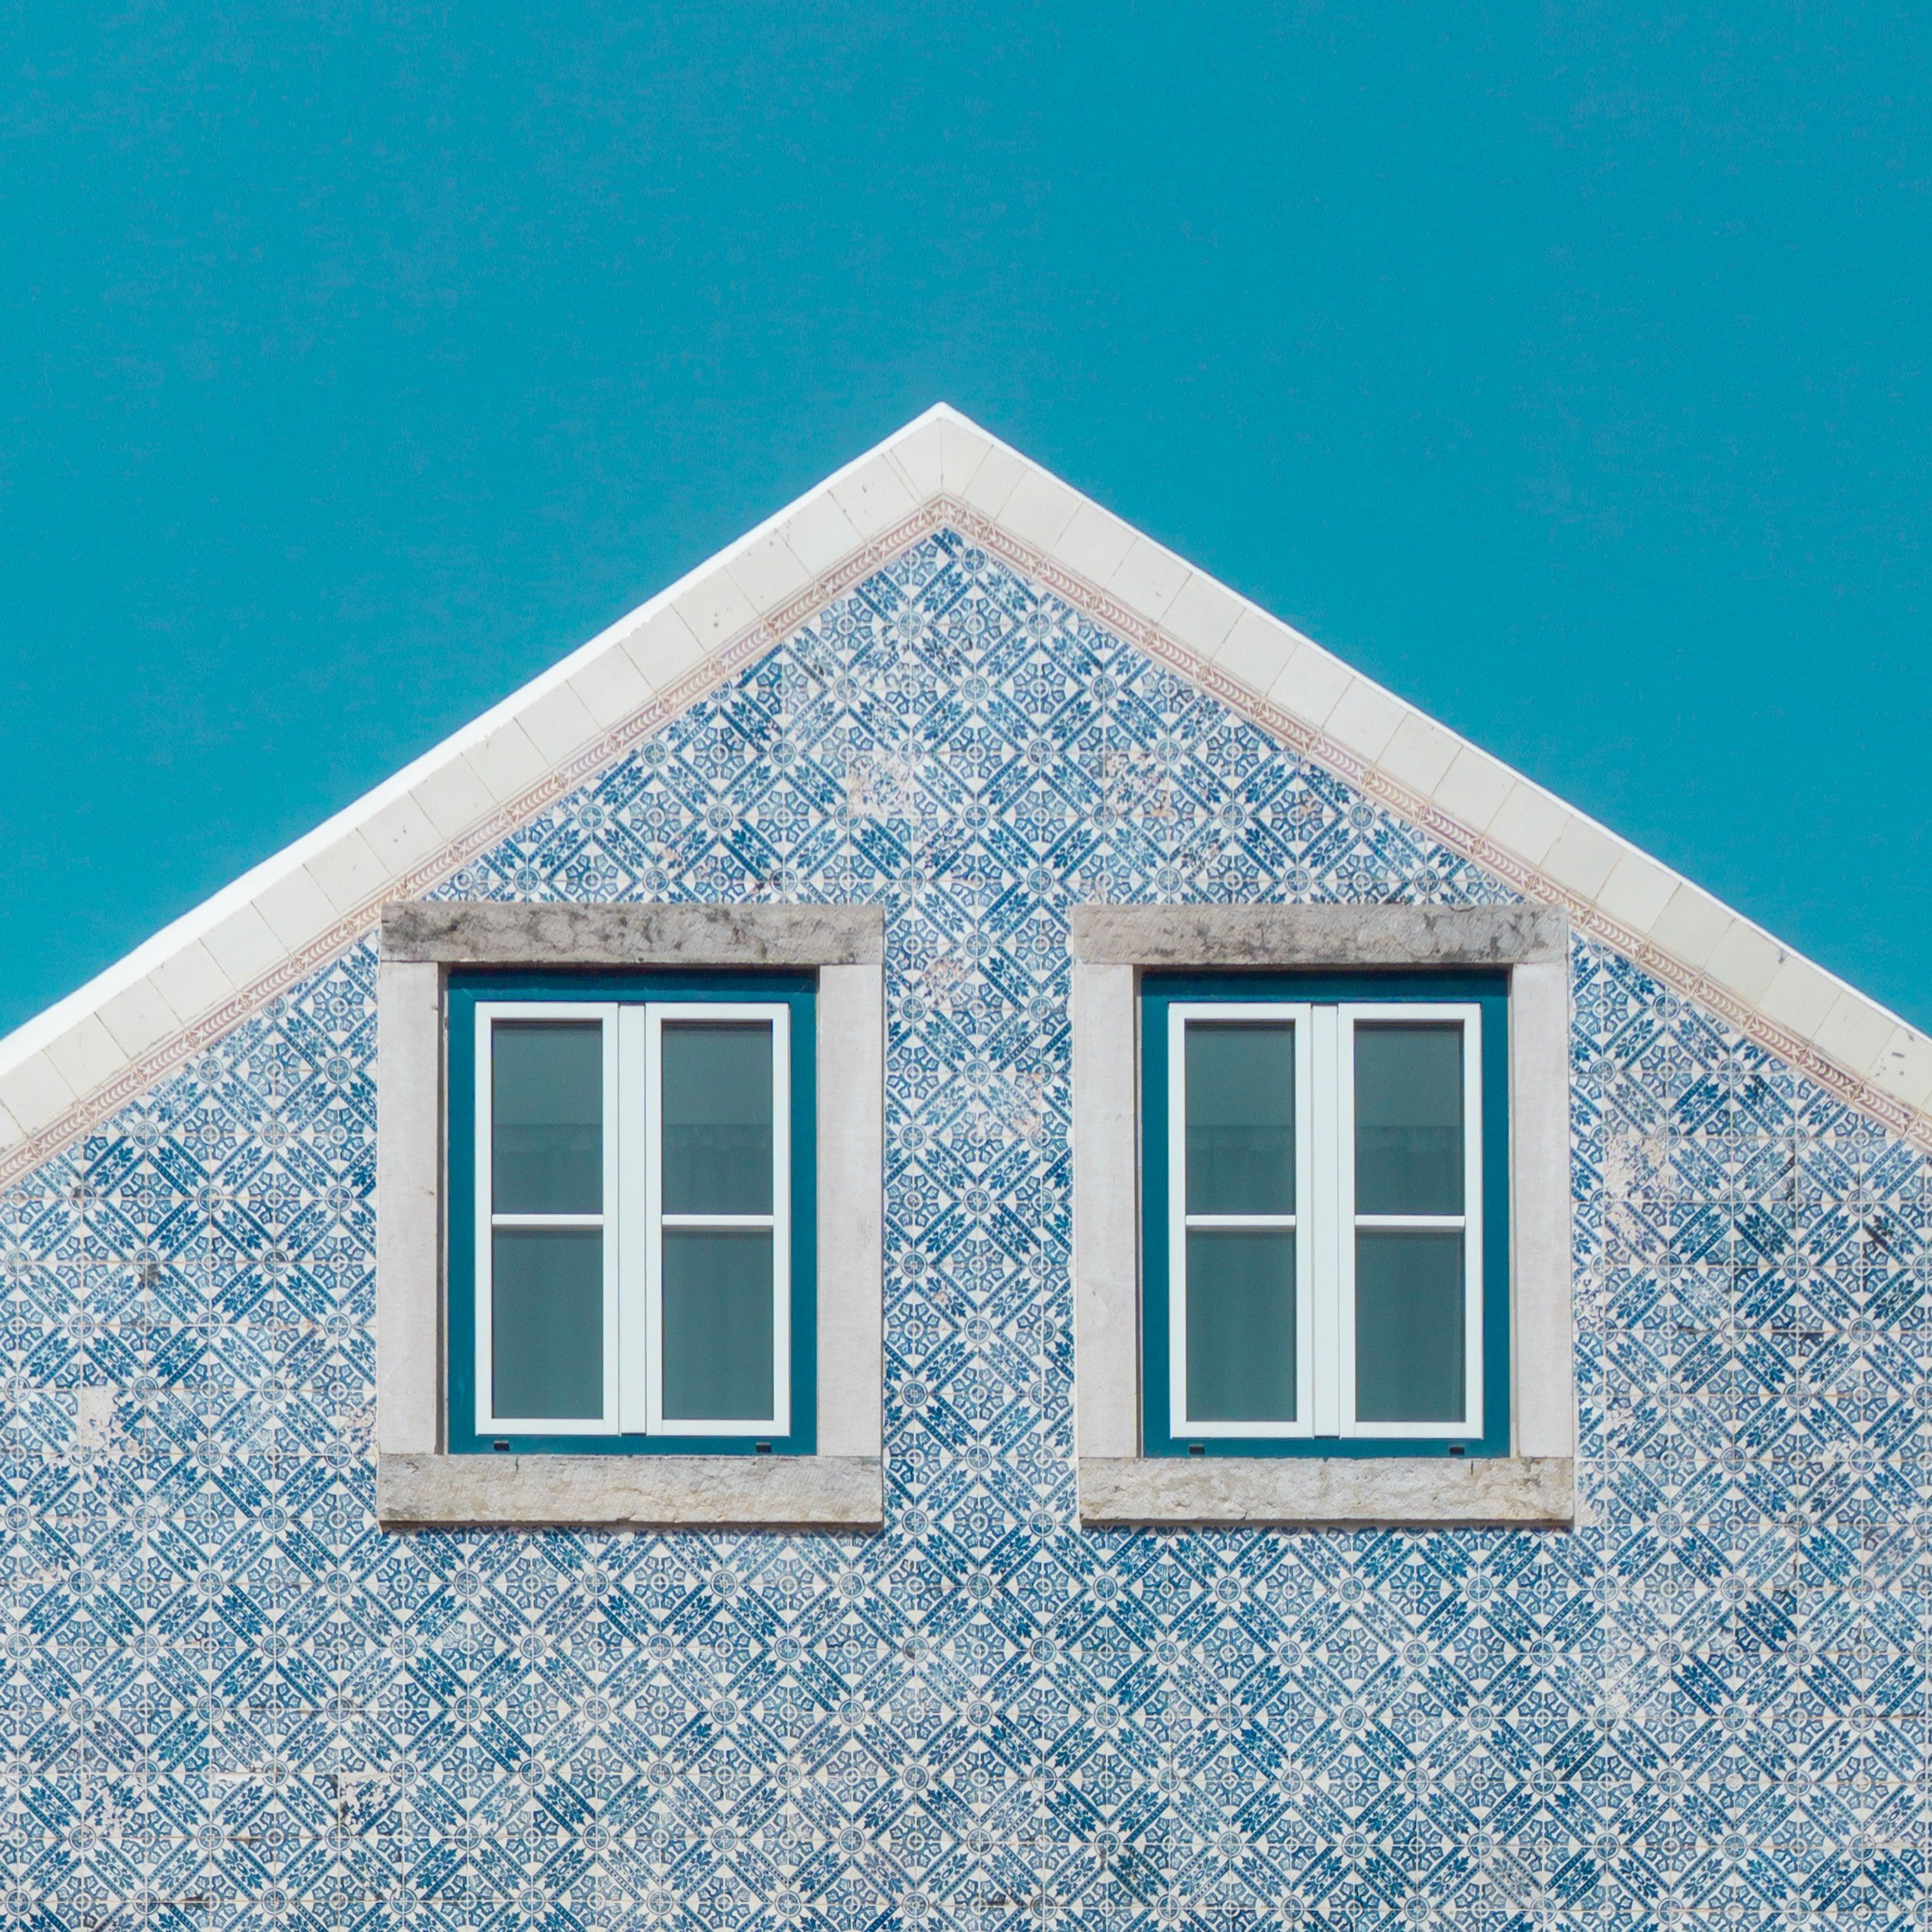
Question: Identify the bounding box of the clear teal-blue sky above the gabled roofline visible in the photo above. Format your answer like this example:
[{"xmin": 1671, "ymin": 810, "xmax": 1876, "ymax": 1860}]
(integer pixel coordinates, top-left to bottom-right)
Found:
[{"xmin": 0, "ymin": 11, "xmax": 1932, "ymax": 1030}]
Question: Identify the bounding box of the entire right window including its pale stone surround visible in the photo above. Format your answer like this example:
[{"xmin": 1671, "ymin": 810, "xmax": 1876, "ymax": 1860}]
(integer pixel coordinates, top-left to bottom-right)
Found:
[{"xmin": 1068, "ymin": 906, "xmax": 1576, "ymax": 1528}]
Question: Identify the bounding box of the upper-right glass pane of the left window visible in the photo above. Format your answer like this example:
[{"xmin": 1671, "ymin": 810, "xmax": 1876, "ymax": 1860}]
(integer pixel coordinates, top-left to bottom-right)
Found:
[{"xmin": 663, "ymin": 1020, "xmax": 771, "ymax": 1205}]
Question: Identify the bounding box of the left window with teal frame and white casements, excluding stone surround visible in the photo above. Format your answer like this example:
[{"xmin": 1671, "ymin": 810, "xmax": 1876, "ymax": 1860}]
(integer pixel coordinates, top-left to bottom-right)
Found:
[{"xmin": 448, "ymin": 976, "xmax": 813, "ymax": 1455}]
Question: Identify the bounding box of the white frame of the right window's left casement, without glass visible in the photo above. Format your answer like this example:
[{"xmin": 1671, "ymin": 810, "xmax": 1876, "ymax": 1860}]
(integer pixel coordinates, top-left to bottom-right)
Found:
[{"xmin": 1167, "ymin": 999, "xmax": 1316, "ymax": 1439}]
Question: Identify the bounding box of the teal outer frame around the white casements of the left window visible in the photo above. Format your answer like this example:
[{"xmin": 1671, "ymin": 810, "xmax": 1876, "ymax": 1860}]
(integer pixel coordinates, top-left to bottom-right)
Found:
[{"xmin": 444, "ymin": 968, "xmax": 817, "ymax": 1455}]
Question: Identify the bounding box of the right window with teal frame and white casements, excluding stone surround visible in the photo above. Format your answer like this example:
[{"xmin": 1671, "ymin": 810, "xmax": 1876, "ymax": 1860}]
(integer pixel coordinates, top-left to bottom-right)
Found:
[{"xmin": 1142, "ymin": 974, "xmax": 1509, "ymax": 1455}]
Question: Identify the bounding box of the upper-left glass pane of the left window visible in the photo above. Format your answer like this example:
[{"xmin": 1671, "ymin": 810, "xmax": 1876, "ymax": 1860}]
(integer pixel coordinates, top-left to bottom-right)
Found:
[{"xmin": 490, "ymin": 1020, "xmax": 603, "ymax": 1213}]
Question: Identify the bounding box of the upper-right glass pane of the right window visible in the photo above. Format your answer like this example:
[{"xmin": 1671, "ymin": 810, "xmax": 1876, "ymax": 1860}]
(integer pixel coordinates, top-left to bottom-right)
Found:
[{"xmin": 1354, "ymin": 1022, "xmax": 1462, "ymax": 1213}]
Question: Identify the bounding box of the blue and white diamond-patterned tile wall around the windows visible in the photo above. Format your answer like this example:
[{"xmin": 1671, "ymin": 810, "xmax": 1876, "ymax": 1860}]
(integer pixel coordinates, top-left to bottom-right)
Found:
[{"xmin": 0, "ymin": 533, "xmax": 1932, "ymax": 1932}]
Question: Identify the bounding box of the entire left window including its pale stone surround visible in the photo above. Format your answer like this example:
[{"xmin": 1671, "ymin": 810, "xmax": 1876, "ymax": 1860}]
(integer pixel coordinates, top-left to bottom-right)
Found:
[{"xmin": 375, "ymin": 900, "xmax": 885, "ymax": 1530}]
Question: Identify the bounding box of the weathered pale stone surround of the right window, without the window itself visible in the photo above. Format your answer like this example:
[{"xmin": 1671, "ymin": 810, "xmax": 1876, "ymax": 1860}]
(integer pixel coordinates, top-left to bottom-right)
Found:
[{"xmin": 1068, "ymin": 906, "xmax": 1576, "ymax": 1528}]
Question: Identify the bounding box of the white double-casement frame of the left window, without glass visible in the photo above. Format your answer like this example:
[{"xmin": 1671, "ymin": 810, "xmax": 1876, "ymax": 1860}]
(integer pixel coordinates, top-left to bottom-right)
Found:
[{"xmin": 474, "ymin": 999, "xmax": 792, "ymax": 1438}]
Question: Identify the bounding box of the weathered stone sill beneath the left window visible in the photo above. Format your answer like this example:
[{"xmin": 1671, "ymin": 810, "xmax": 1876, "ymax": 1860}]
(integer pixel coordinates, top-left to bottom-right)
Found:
[{"xmin": 375, "ymin": 1453, "xmax": 885, "ymax": 1532}]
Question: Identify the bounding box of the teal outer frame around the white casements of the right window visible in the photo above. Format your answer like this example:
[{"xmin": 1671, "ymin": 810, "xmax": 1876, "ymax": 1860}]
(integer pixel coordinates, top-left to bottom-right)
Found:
[{"xmin": 1138, "ymin": 970, "xmax": 1511, "ymax": 1457}]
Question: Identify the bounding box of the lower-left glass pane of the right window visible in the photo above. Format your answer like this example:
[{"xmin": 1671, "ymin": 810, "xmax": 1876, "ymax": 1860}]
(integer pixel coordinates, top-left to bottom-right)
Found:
[{"xmin": 1188, "ymin": 1228, "xmax": 1294, "ymax": 1422}]
